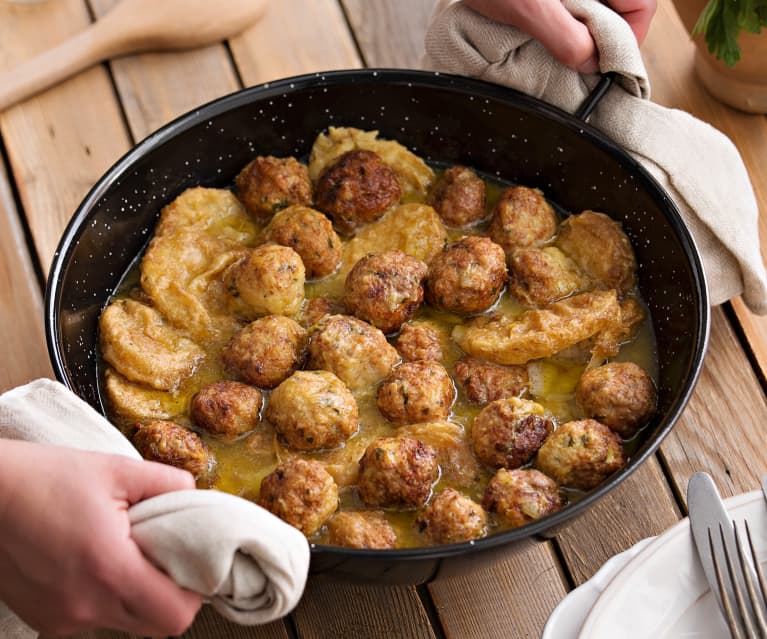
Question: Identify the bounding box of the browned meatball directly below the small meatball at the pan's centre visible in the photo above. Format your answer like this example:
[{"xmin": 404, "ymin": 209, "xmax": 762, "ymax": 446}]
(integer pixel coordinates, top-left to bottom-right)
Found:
[{"xmin": 377, "ymin": 360, "xmax": 455, "ymax": 425}]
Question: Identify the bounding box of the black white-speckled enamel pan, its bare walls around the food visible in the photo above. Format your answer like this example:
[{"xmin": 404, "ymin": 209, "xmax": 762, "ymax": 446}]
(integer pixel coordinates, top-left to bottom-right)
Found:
[{"xmin": 45, "ymin": 69, "xmax": 710, "ymax": 584}]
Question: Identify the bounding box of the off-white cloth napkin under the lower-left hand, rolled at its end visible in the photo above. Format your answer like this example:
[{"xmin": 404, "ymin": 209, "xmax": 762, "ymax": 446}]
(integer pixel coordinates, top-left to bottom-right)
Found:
[{"xmin": 0, "ymin": 379, "xmax": 309, "ymax": 637}]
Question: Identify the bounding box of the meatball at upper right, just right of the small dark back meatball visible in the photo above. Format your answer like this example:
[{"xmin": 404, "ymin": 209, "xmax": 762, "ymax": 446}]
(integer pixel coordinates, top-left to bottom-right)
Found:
[{"xmin": 487, "ymin": 186, "xmax": 557, "ymax": 253}]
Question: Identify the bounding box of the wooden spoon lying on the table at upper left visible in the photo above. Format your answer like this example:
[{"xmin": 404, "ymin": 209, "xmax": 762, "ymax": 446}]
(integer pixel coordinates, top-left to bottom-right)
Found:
[{"xmin": 0, "ymin": 0, "xmax": 267, "ymax": 111}]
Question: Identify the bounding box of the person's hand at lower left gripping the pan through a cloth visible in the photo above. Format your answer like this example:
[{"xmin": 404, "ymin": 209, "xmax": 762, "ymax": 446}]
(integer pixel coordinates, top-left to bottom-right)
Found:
[{"xmin": 0, "ymin": 440, "xmax": 201, "ymax": 636}]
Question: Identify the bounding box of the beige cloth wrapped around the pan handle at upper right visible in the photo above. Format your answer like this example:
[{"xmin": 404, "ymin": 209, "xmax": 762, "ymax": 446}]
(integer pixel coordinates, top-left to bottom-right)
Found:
[{"xmin": 424, "ymin": 0, "xmax": 767, "ymax": 314}]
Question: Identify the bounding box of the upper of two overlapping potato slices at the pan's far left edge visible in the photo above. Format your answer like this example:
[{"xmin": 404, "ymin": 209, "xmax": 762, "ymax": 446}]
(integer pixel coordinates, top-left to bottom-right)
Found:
[{"xmin": 99, "ymin": 300, "xmax": 205, "ymax": 390}]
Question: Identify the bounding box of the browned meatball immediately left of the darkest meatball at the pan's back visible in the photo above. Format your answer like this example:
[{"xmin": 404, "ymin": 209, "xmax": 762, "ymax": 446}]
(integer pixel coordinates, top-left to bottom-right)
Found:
[{"xmin": 236, "ymin": 156, "xmax": 312, "ymax": 222}]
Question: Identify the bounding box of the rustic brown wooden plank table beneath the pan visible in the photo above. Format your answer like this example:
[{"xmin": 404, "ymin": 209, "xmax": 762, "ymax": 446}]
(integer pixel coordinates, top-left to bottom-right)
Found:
[{"xmin": 0, "ymin": 0, "xmax": 767, "ymax": 639}]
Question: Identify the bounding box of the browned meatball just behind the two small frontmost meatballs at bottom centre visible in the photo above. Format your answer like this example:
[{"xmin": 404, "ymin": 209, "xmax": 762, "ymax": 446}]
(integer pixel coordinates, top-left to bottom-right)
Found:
[{"xmin": 358, "ymin": 437, "xmax": 439, "ymax": 508}]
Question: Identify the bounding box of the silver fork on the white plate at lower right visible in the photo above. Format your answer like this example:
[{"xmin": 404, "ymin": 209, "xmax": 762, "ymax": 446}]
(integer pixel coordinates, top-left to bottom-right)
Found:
[{"xmin": 708, "ymin": 521, "xmax": 767, "ymax": 639}]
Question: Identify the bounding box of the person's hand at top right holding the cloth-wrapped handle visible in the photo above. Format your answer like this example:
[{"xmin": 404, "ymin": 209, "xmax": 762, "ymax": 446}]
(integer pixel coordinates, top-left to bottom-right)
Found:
[{"xmin": 464, "ymin": 0, "xmax": 657, "ymax": 73}]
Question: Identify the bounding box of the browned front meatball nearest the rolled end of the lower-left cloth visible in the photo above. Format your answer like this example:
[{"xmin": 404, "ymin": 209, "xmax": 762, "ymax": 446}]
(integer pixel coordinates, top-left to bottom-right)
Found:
[{"xmin": 258, "ymin": 458, "xmax": 338, "ymax": 537}]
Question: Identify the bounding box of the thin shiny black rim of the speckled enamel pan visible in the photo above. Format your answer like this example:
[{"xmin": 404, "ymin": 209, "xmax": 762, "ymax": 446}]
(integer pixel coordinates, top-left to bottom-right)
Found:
[{"xmin": 45, "ymin": 69, "xmax": 711, "ymax": 561}]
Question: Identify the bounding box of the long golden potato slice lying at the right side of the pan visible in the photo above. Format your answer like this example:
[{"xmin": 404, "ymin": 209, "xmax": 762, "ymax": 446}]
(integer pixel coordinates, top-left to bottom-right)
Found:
[{"xmin": 453, "ymin": 290, "xmax": 621, "ymax": 364}]
